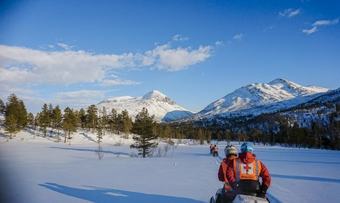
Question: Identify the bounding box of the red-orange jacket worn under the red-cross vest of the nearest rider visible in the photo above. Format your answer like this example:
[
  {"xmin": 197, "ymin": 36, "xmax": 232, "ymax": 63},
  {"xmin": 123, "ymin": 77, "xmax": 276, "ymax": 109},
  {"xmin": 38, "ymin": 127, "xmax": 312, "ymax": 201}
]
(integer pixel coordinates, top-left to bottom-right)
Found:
[{"xmin": 226, "ymin": 152, "xmax": 271, "ymax": 188}]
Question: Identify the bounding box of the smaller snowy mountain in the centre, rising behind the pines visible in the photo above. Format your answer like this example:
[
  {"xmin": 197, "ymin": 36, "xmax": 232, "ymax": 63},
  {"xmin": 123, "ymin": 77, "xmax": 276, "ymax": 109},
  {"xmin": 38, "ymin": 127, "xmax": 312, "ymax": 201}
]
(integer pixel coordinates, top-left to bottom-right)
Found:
[{"xmin": 97, "ymin": 90, "xmax": 192, "ymax": 121}]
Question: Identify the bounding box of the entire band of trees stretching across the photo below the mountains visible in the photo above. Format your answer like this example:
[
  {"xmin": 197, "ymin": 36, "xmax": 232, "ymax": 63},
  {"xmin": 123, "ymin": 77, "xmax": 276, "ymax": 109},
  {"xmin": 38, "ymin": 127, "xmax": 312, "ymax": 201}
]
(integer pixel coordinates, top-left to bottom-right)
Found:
[{"xmin": 0, "ymin": 94, "xmax": 340, "ymax": 152}]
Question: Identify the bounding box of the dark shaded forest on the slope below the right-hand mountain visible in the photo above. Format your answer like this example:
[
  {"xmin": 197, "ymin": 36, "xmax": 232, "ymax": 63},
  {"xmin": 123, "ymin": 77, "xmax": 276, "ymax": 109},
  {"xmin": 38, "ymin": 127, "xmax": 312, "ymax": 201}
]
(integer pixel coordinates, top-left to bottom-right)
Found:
[{"xmin": 186, "ymin": 103, "xmax": 340, "ymax": 150}]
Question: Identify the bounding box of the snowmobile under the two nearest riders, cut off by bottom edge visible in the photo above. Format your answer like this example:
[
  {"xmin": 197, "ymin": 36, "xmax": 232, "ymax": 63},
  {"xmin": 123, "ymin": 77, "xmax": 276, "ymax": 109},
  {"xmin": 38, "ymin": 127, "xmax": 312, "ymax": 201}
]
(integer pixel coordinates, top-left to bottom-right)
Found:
[{"xmin": 209, "ymin": 188, "xmax": 269, "ymax": 203}]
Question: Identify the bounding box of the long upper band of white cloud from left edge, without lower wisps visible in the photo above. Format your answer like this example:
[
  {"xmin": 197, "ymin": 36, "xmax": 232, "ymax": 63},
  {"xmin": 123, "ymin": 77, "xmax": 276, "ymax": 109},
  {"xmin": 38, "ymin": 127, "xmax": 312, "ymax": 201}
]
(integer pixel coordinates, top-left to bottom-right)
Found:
[{"xmin": 0, "ymin": 41, "xmax": 212, "ymax": 84}]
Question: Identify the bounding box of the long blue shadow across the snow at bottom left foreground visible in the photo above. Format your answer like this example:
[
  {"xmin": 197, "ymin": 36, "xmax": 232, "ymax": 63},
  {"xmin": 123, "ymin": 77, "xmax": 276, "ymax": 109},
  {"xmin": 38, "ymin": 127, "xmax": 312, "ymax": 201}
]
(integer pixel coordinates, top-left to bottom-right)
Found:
[{"xmin": 39, "ymin": 183, "xmax": 202, "ymax": 203}]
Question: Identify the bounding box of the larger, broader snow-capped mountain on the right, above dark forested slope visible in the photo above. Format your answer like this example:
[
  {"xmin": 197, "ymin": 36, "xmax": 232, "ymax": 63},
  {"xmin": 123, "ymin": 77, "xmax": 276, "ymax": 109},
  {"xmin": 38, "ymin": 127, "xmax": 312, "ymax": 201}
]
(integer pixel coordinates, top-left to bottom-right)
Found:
[{"xmin": 194, "ymin": 78, "xmax": 328, "ymax": 119}]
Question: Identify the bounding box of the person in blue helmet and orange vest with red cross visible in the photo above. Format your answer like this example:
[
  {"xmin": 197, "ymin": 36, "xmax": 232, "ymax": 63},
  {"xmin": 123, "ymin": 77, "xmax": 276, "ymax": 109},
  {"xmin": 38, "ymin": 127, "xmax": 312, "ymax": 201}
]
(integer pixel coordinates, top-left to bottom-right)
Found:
[{"xmin": 227, "ymin": 143, "xmax": 271, "ymax": 197}]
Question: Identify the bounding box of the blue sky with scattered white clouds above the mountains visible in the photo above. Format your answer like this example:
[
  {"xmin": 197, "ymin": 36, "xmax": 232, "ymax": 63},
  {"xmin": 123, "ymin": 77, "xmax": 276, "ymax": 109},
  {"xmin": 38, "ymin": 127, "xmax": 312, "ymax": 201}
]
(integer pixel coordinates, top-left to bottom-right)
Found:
[{"xmin": 0, "ymin": 0, "xmax": 340, "ymax": 112}]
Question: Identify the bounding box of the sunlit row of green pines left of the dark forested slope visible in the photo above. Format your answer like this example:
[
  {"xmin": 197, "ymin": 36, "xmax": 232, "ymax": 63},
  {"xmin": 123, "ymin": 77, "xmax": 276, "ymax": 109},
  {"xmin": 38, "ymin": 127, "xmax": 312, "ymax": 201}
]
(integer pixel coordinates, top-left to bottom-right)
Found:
[{"xmin": 0, "ymin": 94, "xmax": 210, "ymax": 157}]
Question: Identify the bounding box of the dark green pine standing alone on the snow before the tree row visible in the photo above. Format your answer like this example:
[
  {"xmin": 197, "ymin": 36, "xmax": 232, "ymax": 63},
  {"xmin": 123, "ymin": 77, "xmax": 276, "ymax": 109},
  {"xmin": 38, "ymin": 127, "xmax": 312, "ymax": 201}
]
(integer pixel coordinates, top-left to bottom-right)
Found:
[{"xmin": 130, "ymin": 108, "xmax": 158, "ymax": 158}]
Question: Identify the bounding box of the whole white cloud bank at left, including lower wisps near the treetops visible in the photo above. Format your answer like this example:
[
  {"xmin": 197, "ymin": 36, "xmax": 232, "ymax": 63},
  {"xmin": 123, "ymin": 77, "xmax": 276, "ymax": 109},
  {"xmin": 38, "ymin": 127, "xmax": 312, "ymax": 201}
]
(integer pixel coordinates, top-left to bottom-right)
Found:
[{"xmin": 0, "ymin": 40, "xmax": 213, "ymax": 112}]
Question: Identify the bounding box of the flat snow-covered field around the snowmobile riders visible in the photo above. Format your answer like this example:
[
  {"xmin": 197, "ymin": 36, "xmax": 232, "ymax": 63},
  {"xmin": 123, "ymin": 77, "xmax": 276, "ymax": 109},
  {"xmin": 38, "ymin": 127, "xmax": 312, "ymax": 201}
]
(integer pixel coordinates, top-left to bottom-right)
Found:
[{"xmin": 0, "ymin": 131, "xmax": 340, "ymax": 203}]
